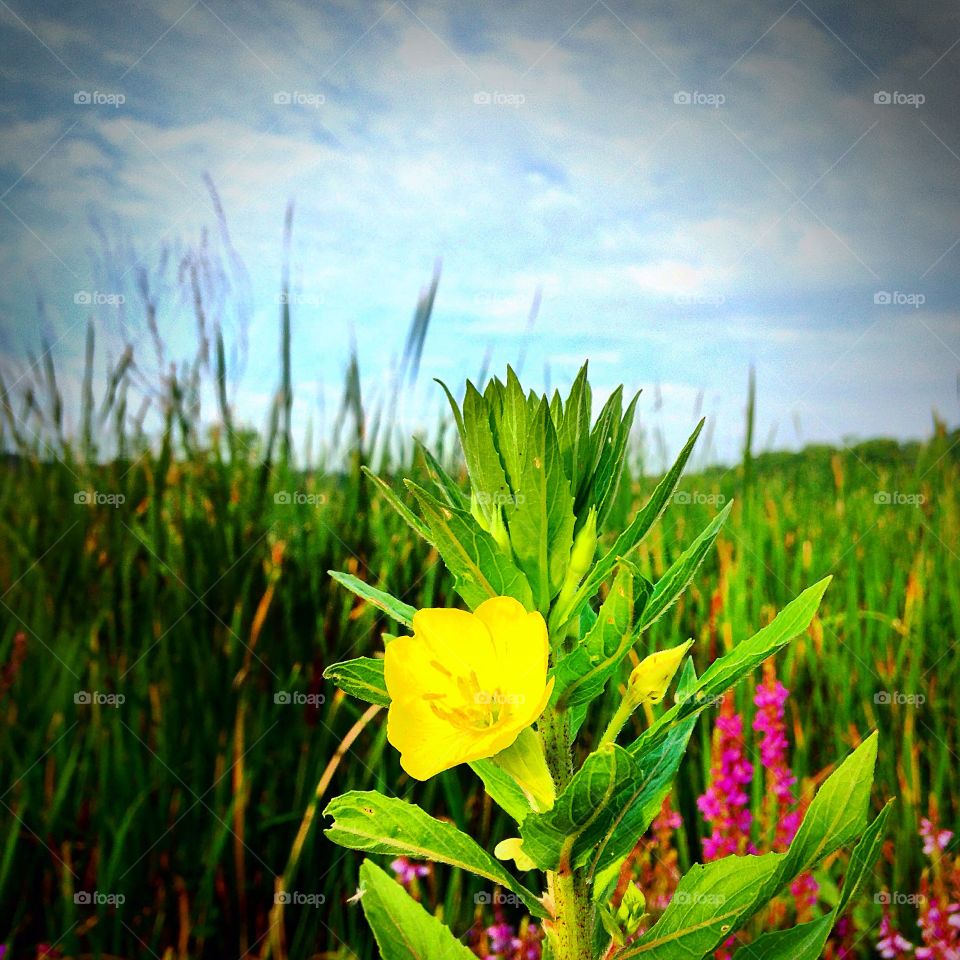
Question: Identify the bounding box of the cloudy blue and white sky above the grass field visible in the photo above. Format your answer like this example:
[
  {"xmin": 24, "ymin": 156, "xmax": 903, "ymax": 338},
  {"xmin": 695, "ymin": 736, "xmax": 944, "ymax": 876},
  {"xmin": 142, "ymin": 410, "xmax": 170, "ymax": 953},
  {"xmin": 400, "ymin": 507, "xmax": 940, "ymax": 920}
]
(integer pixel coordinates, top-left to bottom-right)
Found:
[{"xmin": 0, "ymin": 0, "xmax": 960, "ymax": 459}]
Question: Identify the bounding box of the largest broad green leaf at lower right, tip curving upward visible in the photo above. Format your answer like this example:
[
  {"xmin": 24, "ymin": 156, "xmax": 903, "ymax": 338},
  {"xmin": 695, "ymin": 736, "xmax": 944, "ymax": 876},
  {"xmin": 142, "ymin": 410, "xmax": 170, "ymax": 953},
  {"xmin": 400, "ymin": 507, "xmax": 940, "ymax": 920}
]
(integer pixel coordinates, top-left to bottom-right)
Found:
[{"xmin": 617, "ymin": 734, "xmax": 877, "ymax": 960}]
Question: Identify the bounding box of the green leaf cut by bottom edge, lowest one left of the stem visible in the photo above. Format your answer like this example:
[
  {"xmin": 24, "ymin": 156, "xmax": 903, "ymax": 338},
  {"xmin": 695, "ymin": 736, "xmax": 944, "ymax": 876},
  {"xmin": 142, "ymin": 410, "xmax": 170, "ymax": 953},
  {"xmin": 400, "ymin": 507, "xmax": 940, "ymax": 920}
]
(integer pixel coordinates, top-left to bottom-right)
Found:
[{"xmin": 360, "ymin": 860, "xmax": 476, "ymax": 960}]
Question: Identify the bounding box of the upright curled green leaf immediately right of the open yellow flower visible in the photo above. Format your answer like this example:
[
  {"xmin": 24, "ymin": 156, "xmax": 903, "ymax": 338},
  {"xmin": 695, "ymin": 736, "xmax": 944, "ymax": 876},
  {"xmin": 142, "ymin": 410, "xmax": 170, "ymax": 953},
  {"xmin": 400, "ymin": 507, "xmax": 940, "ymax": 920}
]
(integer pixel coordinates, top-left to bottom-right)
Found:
[{"xmin": 551, "ymin": 564, "xmax": 635, "ymax": 710}]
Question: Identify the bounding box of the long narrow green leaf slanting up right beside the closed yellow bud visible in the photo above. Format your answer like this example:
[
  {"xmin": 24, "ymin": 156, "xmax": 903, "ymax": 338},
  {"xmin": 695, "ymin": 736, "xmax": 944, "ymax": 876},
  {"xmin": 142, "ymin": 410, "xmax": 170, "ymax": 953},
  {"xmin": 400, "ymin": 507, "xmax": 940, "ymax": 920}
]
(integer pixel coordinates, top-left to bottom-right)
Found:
[{"xmin": 638, "ymin": 577, "xmax": 830, "ymax": 756}]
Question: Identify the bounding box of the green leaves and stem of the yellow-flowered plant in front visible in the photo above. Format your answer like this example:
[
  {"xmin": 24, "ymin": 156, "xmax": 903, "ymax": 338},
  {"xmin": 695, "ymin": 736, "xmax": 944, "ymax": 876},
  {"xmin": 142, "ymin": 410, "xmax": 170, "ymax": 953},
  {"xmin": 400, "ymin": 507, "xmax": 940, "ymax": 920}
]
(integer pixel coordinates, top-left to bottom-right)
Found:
[{"xmin": 326, "ymin": 368, "xmax": 886, "ymax": 960}]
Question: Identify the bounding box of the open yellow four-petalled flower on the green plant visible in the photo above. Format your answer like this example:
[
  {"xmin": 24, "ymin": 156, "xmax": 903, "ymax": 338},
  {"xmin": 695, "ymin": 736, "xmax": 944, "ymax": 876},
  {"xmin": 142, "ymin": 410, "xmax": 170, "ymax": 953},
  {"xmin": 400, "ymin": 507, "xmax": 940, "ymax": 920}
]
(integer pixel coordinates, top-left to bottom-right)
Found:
[{"xmin": 384, "ymin": 597, "xmax": 553, "ymax": 780}]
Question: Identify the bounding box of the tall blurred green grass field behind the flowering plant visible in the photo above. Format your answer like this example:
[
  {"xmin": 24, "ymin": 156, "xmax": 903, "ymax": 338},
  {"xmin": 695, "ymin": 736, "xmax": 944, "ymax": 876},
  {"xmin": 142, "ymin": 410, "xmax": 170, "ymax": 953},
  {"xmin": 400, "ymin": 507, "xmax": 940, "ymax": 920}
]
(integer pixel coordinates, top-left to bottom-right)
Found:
[{"xmin": 0, "ymin": 312, "xmax": 960, "ymax": 960}]
